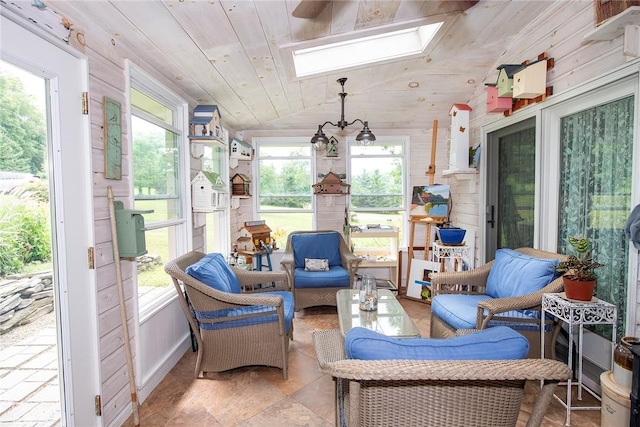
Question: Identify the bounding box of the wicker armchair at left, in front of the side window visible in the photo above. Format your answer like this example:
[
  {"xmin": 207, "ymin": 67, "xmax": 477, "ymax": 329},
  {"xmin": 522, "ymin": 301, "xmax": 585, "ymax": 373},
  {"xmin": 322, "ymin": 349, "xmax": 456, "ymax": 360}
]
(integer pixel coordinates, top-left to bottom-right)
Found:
[{"xmin": 164, "ymin": 251, "xmax": 293, "ymax": 380}]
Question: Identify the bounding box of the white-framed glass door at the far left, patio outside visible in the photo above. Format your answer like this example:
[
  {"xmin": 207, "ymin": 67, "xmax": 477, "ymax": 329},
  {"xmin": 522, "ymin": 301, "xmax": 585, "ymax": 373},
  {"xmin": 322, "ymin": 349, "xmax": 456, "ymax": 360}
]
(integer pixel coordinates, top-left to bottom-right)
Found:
[{"xmin": 0, "ymin": 11, "xmax": 100, "ymax": 426}]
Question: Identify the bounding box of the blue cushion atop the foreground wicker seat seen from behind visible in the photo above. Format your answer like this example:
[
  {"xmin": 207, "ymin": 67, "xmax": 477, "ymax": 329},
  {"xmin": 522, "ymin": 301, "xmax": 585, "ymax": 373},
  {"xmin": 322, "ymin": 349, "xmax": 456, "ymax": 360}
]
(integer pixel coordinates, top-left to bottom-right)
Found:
[{"xmin": 345, "ymin": 326, "xmax": 529, "ymax": 360}]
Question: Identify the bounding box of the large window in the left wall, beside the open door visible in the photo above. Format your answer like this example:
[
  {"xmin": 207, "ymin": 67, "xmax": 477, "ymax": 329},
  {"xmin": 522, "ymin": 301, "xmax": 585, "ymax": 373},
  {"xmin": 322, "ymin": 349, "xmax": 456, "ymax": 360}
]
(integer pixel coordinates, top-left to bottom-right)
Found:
[{"xmin": 129, "ymin": 67, "xmax": 189, "ymax": 317}]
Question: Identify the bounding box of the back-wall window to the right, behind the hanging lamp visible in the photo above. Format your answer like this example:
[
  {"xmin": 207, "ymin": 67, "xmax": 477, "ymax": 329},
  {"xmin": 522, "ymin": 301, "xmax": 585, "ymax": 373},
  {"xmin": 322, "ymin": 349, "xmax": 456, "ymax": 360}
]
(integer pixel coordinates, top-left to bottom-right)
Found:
[{"xmin": 348, "ymin": 137, "xmax": 408, "ymax": 243}]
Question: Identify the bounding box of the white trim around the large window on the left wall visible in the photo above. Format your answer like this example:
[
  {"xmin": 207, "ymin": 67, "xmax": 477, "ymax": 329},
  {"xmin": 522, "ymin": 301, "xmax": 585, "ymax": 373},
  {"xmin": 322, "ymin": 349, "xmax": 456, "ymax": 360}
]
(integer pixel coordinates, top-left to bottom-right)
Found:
[{"xmin": 125, "ymin": 60, "xmax": 193, "ymax": 323}]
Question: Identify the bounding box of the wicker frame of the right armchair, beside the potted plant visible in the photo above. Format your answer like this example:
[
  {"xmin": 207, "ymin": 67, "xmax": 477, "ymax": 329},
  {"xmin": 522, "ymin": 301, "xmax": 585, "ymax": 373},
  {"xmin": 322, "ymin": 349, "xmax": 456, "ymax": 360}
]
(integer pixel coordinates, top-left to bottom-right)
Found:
[{"xmin": 430, "ymin": 248, "xmax": 566, "ymax": 359}]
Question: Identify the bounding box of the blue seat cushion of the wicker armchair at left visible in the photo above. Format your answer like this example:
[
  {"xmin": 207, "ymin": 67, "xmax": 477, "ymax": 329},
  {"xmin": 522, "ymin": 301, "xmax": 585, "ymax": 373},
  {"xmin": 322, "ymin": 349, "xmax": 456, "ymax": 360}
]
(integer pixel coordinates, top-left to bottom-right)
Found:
[{"xmin": 195, "ymin": 291, "xmax": 295, "ymax": 334}]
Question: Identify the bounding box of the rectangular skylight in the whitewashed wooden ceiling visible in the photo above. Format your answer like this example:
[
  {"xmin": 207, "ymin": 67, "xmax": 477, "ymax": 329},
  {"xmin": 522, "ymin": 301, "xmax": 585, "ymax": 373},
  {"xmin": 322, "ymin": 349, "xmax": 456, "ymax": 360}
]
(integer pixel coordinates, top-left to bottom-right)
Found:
[{"xmin": 292, "ymin": 22, "xmax": 442, "ymax": 77}]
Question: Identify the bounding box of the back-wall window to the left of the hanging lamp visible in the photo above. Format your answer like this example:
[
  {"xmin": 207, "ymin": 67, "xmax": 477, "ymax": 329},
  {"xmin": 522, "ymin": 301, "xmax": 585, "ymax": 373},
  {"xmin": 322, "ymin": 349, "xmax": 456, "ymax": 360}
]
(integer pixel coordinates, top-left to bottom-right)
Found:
[{"xmin": 254, "ymin": 138, "xmax": 314, "ymax": 247}]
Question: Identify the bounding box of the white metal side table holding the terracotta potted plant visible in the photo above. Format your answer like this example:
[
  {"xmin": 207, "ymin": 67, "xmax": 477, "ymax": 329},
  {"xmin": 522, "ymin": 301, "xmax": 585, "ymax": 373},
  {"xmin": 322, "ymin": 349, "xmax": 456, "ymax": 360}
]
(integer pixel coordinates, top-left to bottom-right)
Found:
[{"xmin": 540, "ymin": 292, "xmax": 618, "ymax": 425}]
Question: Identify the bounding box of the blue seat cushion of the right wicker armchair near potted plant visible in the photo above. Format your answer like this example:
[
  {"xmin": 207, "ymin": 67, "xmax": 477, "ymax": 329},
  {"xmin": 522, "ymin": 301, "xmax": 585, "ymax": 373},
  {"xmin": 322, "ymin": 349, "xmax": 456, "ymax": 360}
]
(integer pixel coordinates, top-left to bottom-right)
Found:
[{"xmin": 431, "ymin": 294, "xmax": 553, "ymax": 331}]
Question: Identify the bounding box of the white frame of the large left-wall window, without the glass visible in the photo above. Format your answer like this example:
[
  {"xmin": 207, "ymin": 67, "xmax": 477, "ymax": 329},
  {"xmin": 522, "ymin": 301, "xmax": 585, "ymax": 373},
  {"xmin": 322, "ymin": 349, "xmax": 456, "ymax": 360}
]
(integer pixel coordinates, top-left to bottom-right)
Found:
[{"xmin": 126, "ymin": 61, "xmax": 192, "ymax": 323}]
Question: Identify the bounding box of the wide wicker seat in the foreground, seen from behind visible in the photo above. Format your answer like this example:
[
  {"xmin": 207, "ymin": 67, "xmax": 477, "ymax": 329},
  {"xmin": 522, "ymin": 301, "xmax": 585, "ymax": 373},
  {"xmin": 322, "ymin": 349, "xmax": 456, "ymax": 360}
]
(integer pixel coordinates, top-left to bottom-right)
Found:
[{"xmin": 313, "ymin": 330, "xmax": 571, "ymax": 427}]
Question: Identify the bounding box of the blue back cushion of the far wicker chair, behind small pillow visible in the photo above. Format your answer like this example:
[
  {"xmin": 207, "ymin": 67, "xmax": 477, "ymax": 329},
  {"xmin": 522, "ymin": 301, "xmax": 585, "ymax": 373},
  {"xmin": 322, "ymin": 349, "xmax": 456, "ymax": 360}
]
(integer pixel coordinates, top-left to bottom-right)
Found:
[{"xmin": 291, "ymin": 232, "xmax": 342, "ymax": 268}]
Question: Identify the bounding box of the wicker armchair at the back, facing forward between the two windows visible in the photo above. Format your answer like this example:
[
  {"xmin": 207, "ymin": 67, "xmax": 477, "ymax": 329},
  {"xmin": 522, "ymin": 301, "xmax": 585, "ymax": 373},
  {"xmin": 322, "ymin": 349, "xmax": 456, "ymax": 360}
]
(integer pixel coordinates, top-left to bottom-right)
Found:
[{"xmin": 280, "ymin": 230, "xmax": 362, "ymax": 310}]
